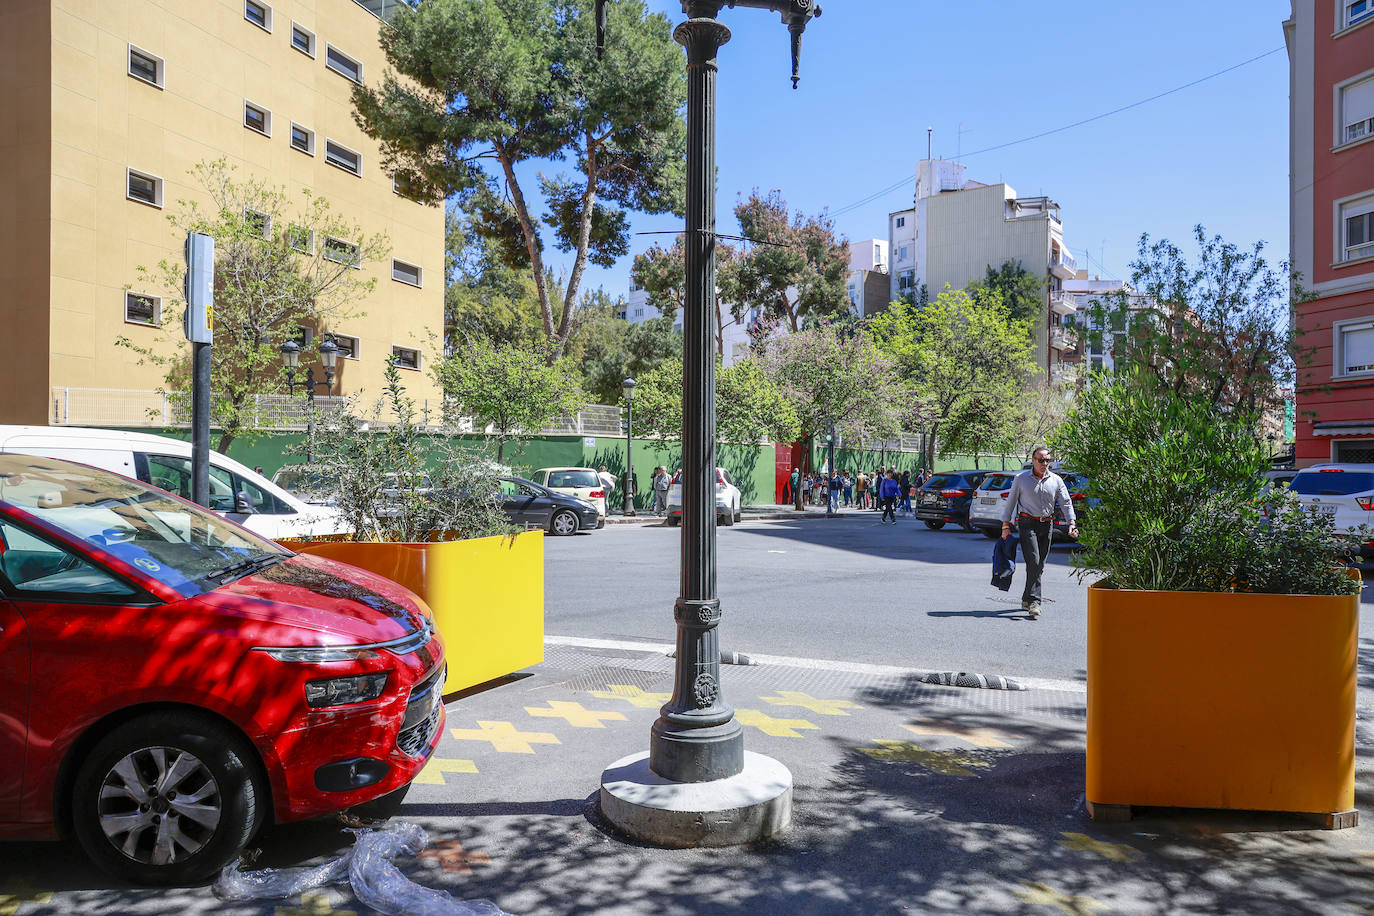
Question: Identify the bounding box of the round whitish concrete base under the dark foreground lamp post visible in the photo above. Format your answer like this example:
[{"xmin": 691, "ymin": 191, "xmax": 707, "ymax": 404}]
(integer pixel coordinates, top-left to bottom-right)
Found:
[{"xmin": 600, "ymin": 751, "xmax": 791, "ymax": 849}]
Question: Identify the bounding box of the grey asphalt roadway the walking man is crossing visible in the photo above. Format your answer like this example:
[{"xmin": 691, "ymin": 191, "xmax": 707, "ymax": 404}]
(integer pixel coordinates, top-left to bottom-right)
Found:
[{"xmin": 545, "ymin": 514, "xmax": 1374, "ymax": 681}]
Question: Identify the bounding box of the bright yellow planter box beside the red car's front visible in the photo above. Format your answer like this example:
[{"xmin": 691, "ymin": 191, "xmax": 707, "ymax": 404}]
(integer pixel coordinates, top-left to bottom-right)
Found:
[{"xmin": 287, "ymin": 531, "xmax": 544, "ymax": 694}]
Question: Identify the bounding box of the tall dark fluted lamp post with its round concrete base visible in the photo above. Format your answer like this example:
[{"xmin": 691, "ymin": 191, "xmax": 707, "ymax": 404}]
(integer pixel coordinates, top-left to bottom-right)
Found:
[{"xmin": 596, "ymin": 0, "xmax": 820, "ymax": 847}]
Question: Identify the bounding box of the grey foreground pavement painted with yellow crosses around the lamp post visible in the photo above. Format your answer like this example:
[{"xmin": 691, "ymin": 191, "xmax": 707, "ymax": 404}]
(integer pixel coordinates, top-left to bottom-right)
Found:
[{"xmin": 10, "ymin": 637, "xmax": 1374, "ymax": 916}]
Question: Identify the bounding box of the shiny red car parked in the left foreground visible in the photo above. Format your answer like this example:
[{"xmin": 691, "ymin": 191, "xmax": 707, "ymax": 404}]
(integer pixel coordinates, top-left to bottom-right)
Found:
[{"xmin": 0, "ymin": 455, "xmax": 444, "ymax": 883}]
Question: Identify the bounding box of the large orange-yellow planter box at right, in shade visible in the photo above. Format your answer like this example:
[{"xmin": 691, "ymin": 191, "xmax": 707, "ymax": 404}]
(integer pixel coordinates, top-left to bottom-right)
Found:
[{"xmin": 1087, "ymin": 585, "xmax": 1359, "ymax": 825}]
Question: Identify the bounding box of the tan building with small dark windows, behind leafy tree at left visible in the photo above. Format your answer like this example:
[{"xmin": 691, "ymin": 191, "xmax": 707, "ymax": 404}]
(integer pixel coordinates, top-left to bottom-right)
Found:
[{"xmin": 0, "ymin": 0, "xmax": 444, "ymax": 426}]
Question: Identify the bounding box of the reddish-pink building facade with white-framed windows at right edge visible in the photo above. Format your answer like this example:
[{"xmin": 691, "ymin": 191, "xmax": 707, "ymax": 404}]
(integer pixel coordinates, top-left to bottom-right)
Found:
[{"xmin": 1283, "ymin": 0, "xmax": 1374, "ymax": 467}]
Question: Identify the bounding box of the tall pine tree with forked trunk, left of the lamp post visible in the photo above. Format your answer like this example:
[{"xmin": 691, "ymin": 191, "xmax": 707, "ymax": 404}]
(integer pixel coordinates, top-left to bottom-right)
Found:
[{"xmin": 353, "ymin": 0, "xmax": 686, "ymax": 360}]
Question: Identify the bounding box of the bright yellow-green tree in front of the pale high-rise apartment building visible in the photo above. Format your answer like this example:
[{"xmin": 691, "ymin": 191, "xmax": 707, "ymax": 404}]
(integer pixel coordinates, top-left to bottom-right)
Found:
[{"xmin": 868, "ymin": 287, "xmax": 1035, "ymax": 467}]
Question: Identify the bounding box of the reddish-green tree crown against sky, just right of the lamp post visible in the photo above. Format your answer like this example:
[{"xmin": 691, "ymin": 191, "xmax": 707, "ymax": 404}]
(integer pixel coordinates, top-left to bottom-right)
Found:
[{"xmin": 719, "ymin": 190, "xmax": 849, "ymax": 331}]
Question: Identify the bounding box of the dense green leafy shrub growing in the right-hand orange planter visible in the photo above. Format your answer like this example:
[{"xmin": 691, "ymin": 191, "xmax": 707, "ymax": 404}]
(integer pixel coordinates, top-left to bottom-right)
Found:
[{"xmin": 1054, "ymin": 372, "xmax": 1359, "ymax": 595}]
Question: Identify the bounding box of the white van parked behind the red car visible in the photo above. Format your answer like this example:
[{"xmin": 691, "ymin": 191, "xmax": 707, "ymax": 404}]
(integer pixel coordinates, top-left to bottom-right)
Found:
[{"xmin": 0, "ymin": 426, "xmax": 346, "ymax": 538}]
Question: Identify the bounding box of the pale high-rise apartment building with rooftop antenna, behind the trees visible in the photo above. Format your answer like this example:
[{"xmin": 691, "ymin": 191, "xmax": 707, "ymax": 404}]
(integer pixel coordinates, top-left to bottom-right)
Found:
[{"xmin": 888, "ymin": 159, "xmax": 1076, "ymax": 379}]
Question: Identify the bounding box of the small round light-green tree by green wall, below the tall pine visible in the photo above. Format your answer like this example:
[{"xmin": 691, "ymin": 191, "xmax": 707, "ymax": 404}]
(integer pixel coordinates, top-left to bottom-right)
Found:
[{"xmin": 433, "ymin": 336, "xmax": 585, "ymax": 460}]
